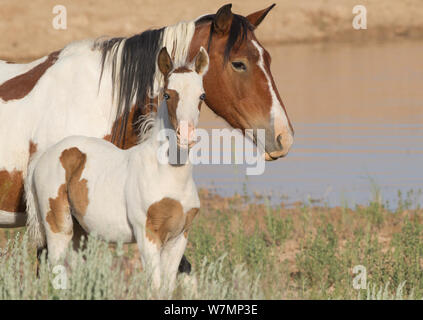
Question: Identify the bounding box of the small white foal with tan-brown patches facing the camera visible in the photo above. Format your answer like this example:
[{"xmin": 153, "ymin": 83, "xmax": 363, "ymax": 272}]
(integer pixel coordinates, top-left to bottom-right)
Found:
[{"xmin": 25, "ymin": 47, "xmax": 209, "ymax": 289}]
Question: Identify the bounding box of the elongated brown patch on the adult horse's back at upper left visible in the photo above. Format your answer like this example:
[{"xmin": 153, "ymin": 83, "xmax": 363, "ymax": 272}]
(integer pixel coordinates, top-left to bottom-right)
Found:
[{"xmin": 0, "ymin": 51, "xmax": 60, "ymax": 101}]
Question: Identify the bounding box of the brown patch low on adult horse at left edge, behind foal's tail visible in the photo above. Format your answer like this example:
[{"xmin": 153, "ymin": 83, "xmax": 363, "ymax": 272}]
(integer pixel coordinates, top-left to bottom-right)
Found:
[{"xmin": 0, "ymin": 170, "xmax": 26, "ymax": 212}]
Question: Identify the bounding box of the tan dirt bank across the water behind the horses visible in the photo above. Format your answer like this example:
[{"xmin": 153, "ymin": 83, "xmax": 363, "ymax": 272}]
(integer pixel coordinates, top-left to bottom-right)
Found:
[{"xmin": 0, "ymin": 0, "xmax": 423, "ymax": 61}]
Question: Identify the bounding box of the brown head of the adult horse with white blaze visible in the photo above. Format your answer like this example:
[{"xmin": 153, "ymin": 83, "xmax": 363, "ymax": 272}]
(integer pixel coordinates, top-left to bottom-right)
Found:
[{"xmin": 189, "ymin": 4, "xmax": 294, "ymax": 160}]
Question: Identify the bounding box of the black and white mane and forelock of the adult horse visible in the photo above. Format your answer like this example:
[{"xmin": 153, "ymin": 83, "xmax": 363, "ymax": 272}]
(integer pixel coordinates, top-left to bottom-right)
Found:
[{"xmin": 95, "ymin": 14, "xmax": 254, "ymax": 145}]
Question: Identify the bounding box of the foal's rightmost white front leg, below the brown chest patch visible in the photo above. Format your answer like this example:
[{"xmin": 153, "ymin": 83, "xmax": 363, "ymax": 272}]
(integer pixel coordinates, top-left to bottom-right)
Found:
[{"xmin": 161, "ymin": 233, "xmax": 188, "ymax": 291}]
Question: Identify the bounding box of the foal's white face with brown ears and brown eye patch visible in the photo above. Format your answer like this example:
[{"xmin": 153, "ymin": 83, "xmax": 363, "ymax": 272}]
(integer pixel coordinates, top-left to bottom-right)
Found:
[{"xmin": 157, "ymin": 47, "xmax": 209, "ymax": 148}]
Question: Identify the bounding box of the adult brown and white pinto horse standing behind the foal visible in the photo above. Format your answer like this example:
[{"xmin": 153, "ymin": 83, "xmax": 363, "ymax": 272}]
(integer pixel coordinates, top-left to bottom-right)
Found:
[{"xmin": 0, "ymin": 4, "xmax": 293, "ymax": 232}]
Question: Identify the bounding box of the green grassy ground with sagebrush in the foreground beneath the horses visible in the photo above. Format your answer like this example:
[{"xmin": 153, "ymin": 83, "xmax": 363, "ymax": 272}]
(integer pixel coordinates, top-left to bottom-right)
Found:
[{"xmin": 0, "ymin": 189, "xmax": 423, "ymax": 299}]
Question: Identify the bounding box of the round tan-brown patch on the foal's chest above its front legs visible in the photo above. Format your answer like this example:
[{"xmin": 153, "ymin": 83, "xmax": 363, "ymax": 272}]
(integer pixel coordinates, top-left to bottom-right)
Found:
[{"xmin": 146, "ymin": 197, "xmax": 184, "ymax": 248}]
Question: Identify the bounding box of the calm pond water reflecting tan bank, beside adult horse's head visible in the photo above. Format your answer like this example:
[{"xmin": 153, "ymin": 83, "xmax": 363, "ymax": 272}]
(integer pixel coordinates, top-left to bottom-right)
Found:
[{"xmin": 194, "ymin": 42, "xmax": 423, "ymax": 206}]
